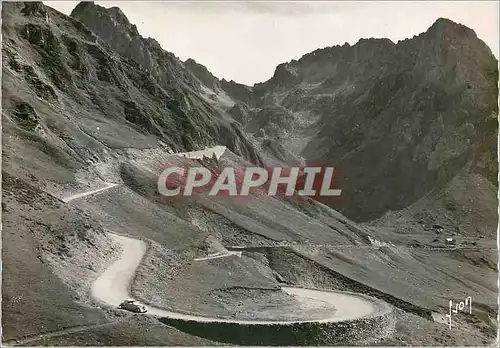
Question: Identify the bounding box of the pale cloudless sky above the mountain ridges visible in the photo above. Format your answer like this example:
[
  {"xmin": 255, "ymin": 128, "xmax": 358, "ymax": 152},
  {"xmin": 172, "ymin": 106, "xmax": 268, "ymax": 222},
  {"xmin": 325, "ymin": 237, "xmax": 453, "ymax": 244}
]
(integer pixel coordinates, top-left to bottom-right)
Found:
[{"xmin": 44, "ymin": 1, "xmax": 499, "ymax": 85}]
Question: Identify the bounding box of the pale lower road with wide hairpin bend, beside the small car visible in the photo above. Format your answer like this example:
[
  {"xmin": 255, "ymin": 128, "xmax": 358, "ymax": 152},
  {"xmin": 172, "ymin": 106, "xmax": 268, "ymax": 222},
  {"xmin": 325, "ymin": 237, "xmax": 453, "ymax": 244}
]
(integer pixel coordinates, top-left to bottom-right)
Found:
[{"xmin": 92, "ymin": 233, "xmax": 387, "ymax": 325}]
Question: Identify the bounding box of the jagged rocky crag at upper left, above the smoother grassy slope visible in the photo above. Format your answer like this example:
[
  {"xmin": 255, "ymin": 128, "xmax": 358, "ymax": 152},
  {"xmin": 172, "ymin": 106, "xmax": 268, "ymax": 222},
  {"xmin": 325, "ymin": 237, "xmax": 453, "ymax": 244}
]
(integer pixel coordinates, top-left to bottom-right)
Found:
[{"xmin": 3, "ymin": 3, "xmax": 258, "ymax": 167}]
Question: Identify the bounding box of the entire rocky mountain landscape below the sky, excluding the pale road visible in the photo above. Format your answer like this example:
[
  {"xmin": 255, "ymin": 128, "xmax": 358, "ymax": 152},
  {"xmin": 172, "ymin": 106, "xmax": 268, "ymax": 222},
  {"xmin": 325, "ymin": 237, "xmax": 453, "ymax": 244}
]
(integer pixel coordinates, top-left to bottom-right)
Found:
[{"xmin": 2, "ymin": 3, "xmax": 497, "ymax": 346}]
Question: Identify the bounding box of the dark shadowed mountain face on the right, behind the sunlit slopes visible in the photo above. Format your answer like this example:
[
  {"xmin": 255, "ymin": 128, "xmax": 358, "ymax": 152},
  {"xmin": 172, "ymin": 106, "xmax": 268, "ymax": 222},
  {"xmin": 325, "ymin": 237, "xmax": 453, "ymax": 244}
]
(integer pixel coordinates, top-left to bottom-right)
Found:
[{"xmin": 216, "ymin": 19, "xmax": 498, "ymax": 220}]
